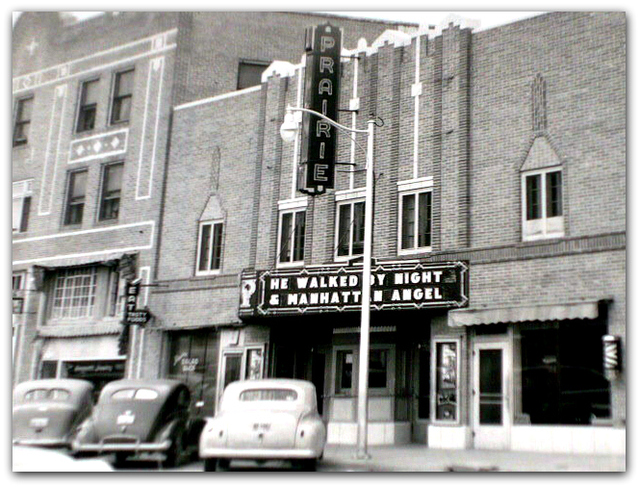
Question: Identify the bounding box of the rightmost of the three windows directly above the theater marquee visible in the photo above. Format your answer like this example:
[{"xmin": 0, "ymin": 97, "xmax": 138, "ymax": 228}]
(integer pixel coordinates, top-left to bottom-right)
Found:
[{"xmin": 400, "ymin": 191, "xmax": 432, "ymax": 253}]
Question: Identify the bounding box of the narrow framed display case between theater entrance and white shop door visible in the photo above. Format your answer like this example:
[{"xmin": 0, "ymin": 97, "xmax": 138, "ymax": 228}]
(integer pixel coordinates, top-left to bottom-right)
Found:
[{"xmin": 435, "ymin": 342, "xmax": 459, "ymax": 421}]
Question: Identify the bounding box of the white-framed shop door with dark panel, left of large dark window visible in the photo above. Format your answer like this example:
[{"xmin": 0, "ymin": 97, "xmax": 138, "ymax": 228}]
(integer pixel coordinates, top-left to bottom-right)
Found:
[{"xmin": 473, "ymin": 342, "xmax": 511, "ymax": 450}]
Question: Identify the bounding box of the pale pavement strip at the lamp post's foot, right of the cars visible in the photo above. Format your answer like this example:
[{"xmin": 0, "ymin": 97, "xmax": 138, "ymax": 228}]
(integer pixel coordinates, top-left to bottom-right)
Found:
[{"xmin": 322, "ymin": 444, "xmax": 626, "ymax": 472}]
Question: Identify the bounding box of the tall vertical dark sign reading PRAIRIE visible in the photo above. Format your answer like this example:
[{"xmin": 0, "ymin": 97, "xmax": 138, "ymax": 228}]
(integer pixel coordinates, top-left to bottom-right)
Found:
[{"xmin": 298, "ymin": 24, "xmax": 342, "ymax": 195}]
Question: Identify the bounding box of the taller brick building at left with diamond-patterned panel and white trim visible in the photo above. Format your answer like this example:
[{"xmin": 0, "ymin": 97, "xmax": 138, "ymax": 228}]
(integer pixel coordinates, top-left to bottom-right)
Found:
[{"xmin": 12, "ymin": 12, "xmax": 400, "ymax": 390}]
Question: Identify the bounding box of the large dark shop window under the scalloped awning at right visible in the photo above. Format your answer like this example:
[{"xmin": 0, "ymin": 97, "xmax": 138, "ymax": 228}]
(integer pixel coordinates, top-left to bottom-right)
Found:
[{"xmin": 520, "ymin": 320, "xmax": 611, "ymax": 424}]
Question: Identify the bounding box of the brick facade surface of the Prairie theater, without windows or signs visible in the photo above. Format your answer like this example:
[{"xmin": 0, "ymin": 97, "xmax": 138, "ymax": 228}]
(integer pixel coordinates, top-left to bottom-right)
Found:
[{"xmin": 153, "ymin": 13, "xmax": 626, "ymax": 454}]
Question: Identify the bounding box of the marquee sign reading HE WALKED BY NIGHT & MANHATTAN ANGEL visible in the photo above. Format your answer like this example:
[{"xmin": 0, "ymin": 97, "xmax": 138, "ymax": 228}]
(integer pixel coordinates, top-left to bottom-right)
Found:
[{"xmin": 239, "ymin": 262, "xmax": 468, "ymax": 316}]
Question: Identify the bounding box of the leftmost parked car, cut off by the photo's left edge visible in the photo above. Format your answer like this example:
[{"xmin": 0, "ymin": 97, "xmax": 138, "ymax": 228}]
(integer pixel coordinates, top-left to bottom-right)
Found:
[{"xmin": 13, "ymin": 379, "xmax": 93, "ymax": 447}]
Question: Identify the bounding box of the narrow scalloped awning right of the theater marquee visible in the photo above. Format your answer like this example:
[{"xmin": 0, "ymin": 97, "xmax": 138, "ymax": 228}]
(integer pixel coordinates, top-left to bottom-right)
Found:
[{"xmin": 449, "ymin": 301, "xmax": 598, "ymax": 327}]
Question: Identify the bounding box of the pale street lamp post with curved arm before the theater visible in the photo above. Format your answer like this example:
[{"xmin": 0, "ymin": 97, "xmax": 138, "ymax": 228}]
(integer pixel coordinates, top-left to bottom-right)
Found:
[{"xmin": 280, "ymin": 107, "xmax": 376, "ymax": 459}]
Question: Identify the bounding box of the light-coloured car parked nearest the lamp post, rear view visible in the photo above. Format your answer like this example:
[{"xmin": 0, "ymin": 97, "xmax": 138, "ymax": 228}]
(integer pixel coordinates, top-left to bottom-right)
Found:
[{"xmin": 200, "ymin": 379, "xmax": 326, "ymax": 472}]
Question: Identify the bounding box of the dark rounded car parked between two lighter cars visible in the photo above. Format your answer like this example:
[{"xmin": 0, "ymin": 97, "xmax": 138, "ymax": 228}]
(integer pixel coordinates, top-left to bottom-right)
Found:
[{"xmin": 72, "ymin": 379, "xmax": 196, "ymax": 467}]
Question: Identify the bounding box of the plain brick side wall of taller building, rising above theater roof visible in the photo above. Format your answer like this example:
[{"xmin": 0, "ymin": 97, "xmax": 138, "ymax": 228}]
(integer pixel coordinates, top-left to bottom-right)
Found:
[{"xmin": 176, "ymin": 12, "xmax": 417, "ymax": 104}]
